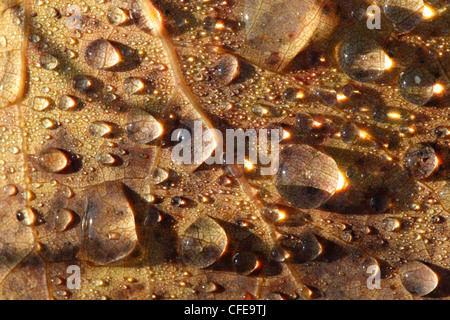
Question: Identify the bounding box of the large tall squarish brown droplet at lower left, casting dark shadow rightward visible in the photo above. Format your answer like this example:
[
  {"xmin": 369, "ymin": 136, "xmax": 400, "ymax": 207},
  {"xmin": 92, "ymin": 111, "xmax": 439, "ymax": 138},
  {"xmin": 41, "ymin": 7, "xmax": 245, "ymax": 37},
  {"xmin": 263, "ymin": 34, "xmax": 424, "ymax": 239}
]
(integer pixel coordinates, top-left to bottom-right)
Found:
[{"xmin": 80, "ymin": 181, "xmax": 137, "ymax": 265}]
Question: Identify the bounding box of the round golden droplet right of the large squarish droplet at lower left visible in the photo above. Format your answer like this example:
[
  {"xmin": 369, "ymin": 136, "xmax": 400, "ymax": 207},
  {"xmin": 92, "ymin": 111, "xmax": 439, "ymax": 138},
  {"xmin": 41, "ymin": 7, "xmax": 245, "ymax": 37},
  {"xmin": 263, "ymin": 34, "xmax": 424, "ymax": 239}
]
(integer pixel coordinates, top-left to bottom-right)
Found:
[{"xmin": 181, "ymin": 218, "xmax": 228, "ymax": 268}]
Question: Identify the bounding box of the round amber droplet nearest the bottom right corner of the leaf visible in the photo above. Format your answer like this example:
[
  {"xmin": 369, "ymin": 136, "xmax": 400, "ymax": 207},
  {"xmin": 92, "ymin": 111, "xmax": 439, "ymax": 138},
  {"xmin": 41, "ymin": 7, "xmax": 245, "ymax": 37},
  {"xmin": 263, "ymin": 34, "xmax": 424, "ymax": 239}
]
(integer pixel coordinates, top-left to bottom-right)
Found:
[{"xmin": 400, "ymin": 261, "xmax": 439, "ymax": 296}]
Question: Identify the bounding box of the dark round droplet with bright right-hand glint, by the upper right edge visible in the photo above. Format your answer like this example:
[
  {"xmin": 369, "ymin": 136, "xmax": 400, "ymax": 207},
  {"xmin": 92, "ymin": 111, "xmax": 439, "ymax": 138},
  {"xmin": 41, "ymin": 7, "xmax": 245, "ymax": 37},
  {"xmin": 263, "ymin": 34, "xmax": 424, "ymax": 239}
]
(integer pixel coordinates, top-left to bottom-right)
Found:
[{"xmin": 398, "ymin": 67, "xmax": 436, "ymax": 106}]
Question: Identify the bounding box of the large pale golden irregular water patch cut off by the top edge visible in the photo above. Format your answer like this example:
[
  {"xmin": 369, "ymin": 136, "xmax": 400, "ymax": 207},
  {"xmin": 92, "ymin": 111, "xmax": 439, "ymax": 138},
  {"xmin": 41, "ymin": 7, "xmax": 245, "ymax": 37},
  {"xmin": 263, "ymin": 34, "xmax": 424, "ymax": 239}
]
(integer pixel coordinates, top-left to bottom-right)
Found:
[{"xmin": 236, "ymin": 0, "xmax": 335, "ymax": 69}]
